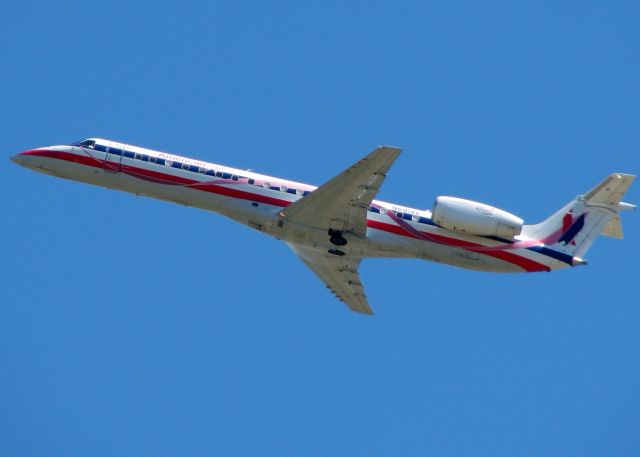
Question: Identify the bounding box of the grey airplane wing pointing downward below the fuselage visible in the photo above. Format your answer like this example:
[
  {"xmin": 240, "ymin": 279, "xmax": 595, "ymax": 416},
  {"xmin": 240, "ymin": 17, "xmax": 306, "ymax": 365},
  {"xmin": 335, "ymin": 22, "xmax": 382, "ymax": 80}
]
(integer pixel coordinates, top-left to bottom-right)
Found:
[{"xmin": 287, "ymin": 243, "xmax": 373, "ymax": 314}]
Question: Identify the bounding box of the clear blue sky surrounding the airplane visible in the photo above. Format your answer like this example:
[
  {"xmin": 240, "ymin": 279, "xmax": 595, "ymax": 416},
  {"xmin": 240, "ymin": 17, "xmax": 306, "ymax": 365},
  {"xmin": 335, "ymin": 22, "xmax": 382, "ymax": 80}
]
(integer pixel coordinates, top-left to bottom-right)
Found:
[{"xmin": 0, "ymin": 1, "xmax": 640, "ymax": 457}]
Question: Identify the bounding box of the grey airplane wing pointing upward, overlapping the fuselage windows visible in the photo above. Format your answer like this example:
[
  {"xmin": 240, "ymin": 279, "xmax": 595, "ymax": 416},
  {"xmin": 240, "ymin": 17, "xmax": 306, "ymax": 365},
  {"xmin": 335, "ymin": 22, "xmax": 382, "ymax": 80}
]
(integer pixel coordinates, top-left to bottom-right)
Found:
[{"xmin": 280, "ymin": 146, "xmax": 401, "ymax": 237}]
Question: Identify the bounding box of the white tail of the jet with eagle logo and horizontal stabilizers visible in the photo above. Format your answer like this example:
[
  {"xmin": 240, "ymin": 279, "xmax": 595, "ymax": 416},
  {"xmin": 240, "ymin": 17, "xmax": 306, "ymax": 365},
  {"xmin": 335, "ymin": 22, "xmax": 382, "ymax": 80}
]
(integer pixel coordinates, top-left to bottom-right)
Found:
[{"xmin": 522, "ymin": 173, "xmax": 636, "ymax": 258}]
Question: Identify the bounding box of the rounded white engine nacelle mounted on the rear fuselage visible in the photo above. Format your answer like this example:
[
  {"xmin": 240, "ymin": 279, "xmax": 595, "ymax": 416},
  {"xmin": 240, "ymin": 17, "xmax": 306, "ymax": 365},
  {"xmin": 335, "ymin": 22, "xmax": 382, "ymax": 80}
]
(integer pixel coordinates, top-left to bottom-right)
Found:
[{"xmin": 431, "ymin": 197, "xmax": 524, "ymax": 238}]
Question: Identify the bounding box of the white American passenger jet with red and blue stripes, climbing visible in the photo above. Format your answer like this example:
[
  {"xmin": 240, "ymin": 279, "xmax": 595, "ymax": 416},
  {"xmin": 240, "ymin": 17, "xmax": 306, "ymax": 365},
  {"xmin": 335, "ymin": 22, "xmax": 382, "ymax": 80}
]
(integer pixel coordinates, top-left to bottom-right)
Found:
[{"xmin": 11, "ymin": 138, "xmax": 636, "ymax": 314}]
